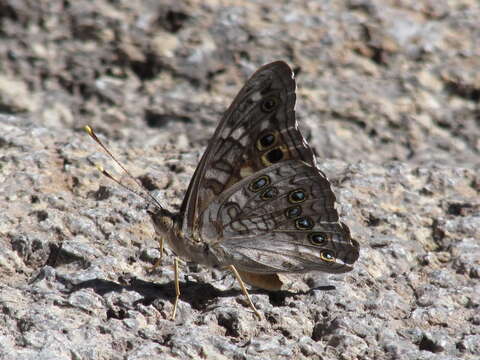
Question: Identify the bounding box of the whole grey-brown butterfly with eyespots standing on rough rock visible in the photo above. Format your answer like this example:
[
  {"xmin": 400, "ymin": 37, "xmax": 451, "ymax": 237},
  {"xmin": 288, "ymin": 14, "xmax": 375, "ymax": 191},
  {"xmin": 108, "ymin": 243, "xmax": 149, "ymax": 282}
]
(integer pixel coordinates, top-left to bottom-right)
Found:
[{"xmin": 87, "ymin": 61, "xmax": 360, "ymax": 318}]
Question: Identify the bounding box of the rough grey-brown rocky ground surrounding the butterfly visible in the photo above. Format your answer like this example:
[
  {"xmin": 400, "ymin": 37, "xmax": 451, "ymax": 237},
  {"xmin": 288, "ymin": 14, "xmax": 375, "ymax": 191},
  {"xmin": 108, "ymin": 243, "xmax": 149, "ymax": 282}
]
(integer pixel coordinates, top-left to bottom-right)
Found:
[{"xmin": 0, "ymin": 0, "xmax": 480, "ymax": 360}]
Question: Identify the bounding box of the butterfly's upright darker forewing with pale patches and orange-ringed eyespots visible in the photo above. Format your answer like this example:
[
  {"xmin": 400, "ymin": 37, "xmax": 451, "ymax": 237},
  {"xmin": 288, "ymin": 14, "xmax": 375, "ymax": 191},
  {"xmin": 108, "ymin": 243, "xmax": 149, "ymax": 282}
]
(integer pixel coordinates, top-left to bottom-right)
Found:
[{"xmin": 181, "ymin": 61, "xmax": 315, "ymax": 233}]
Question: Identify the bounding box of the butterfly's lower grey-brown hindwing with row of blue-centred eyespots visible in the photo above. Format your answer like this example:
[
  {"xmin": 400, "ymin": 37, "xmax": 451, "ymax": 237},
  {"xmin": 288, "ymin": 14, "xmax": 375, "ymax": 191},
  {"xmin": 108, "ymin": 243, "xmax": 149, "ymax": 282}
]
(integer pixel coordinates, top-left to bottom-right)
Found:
[{"xmin": 200, "ymin": 160, "xmax": 358, "ymax": 273}]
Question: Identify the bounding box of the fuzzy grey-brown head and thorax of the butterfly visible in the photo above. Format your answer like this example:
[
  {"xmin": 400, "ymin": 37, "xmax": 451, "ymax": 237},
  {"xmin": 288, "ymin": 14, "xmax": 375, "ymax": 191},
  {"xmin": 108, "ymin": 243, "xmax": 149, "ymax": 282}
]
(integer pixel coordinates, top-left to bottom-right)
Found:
[{"xmin": 149, "ymin": 208, "xmax": 229, "ymax": 268}]
